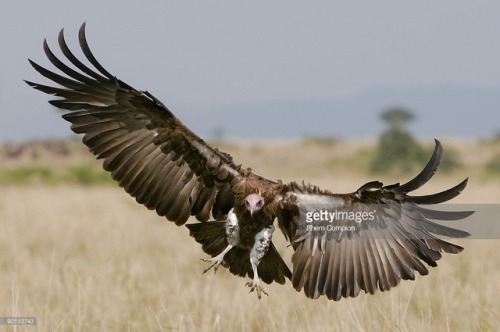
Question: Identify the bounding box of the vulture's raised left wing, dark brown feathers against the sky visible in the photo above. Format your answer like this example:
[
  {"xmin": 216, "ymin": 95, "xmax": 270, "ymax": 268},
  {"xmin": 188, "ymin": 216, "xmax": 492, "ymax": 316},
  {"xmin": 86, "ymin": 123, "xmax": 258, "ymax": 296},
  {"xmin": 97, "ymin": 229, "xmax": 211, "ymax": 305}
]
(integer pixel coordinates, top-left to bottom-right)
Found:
[{"xmin": 26, "ymin": 24, "xmax": 239, "ymax": 225}]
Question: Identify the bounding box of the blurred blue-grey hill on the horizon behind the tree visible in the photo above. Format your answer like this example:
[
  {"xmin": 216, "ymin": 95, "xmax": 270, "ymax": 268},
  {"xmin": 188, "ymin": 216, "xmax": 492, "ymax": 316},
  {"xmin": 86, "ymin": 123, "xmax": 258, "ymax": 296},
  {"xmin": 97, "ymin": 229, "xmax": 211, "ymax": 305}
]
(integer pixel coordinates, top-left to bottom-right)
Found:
[{"xmin": 183, "ymin": 87, "xmax": 500, "ymax": 139}]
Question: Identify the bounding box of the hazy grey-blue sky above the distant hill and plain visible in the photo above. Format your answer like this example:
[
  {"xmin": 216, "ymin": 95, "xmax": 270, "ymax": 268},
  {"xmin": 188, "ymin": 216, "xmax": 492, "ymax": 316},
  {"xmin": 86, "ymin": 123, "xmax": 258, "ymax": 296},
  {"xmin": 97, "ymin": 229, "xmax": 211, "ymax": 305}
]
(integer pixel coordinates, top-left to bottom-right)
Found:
[{"xmin": 0, "ymin": 0, "xmax": 500, "ymax": 141}]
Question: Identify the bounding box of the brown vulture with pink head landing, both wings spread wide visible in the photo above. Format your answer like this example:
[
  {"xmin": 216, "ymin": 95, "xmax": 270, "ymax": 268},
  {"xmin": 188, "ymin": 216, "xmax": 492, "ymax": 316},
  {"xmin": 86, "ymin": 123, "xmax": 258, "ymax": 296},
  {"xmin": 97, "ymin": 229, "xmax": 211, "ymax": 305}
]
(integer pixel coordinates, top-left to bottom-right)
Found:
[{"xmin": 26, "ymin": 23, "xmax": 473, "ymax": 301}]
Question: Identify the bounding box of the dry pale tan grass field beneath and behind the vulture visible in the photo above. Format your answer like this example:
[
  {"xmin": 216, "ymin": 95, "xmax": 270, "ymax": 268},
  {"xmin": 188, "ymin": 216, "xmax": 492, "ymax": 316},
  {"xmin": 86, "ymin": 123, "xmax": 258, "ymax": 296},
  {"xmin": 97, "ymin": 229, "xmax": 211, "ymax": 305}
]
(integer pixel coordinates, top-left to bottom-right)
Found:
[{"xmin": 0, "ymin": 140, "xmax": 500, "ymax": 331}]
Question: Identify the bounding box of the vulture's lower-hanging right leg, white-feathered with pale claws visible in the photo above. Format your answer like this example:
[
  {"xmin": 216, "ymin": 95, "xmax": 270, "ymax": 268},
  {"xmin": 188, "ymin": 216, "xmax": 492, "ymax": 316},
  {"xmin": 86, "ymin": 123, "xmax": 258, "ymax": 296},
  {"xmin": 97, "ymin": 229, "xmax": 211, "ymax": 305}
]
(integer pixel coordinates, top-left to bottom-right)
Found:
[{"xmin": 246, "ymin": 225, "xmax": 274, "ymax": 300}]
